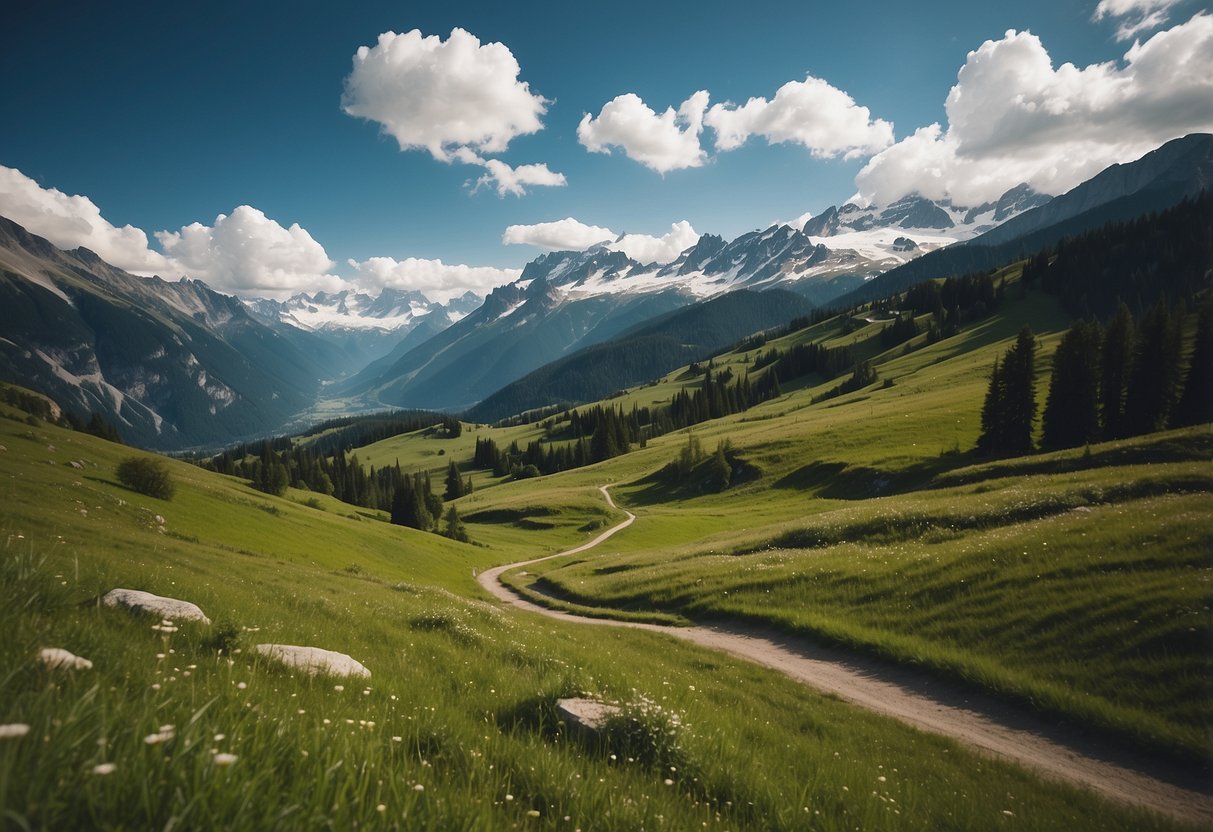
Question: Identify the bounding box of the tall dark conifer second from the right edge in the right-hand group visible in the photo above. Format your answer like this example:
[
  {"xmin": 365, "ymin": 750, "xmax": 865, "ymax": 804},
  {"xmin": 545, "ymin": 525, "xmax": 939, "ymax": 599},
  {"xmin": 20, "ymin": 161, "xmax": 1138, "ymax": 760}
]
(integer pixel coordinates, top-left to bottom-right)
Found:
[{"xmin": 1124, "ymin": 301, "xmax": 1181, "ymax": 435}]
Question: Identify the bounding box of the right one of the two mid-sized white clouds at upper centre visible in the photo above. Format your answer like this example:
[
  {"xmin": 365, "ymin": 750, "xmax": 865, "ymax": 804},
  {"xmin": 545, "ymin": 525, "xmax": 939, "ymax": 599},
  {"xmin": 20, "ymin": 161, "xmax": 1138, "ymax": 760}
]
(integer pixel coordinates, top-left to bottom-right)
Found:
[{"xmin": 704, "ymin": 75, "xmax": 893, "ymax": 159}]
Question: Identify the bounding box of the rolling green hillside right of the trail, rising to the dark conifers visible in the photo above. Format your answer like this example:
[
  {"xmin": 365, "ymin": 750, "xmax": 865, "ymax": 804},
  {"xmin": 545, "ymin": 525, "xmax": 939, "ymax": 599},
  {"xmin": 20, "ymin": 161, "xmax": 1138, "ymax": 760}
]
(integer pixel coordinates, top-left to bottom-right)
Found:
[{"xmin": 373, "ymin": 287, "xmax": 1213, "ymax": 764}]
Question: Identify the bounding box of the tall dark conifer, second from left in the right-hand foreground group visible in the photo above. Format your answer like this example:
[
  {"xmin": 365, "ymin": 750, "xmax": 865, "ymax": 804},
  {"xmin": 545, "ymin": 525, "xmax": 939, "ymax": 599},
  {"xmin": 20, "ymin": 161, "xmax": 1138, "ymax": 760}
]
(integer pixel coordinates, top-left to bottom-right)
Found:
[{"xmin": 1041, "ymin": 320, "xmax": 1099, "ymax": 449}]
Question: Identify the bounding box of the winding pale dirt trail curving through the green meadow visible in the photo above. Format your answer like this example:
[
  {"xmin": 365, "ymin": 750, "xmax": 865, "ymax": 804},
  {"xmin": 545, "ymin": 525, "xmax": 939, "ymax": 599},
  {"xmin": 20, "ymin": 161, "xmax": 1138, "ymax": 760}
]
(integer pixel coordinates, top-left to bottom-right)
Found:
[{"xmin": 477, "ymin": 485, "xmax": 1213, "ymax": 825}]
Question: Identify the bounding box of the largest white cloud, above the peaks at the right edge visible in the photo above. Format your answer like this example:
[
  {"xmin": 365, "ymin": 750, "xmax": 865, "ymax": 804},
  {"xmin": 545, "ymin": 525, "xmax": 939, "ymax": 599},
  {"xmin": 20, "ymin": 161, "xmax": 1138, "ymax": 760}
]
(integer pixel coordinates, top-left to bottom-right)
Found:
[{"xmin": 855, "ymin": 13, "xmax": 1213, "ymax": 205}]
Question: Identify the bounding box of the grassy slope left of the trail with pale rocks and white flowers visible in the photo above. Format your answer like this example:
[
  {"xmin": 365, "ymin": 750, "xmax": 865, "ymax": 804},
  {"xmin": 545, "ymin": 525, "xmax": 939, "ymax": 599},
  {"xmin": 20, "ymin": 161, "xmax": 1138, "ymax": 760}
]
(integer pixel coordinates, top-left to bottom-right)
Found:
[{"xmin": 0, "ymin": 409, "xmax": 1193, "ymax": 830}]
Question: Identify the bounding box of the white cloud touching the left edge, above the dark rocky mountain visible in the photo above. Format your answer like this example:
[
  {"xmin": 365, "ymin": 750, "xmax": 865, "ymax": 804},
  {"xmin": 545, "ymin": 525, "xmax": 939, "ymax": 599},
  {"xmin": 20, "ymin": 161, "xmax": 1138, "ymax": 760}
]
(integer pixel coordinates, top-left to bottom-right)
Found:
[{"xmin": 0, "ymin": 165, "xmax": 176, "ymax": 277}]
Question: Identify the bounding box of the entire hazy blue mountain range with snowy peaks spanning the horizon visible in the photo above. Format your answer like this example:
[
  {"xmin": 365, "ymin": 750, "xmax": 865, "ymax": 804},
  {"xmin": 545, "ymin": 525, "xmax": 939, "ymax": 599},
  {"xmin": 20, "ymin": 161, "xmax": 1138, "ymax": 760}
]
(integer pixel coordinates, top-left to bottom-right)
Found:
[{"xmin": 0, "ymin": 135, "xmax": 1213, "ymax": 450}]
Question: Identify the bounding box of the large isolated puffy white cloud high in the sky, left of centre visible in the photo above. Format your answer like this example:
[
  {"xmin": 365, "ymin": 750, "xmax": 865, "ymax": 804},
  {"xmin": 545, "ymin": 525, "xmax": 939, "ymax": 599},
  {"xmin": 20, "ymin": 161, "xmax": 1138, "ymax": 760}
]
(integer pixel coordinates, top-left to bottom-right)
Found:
[{"xmin": 342, "ymin": 29, "xmax": 549, "ymax": 161}]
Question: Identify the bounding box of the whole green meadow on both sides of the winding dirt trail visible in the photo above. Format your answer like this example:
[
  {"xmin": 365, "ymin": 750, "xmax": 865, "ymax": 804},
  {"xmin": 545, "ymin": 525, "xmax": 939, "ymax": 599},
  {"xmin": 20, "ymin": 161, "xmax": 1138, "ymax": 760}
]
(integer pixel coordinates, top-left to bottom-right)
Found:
[{"xmin": 0, "ymin": 283, "xmax": 1213, "ymax": 831}]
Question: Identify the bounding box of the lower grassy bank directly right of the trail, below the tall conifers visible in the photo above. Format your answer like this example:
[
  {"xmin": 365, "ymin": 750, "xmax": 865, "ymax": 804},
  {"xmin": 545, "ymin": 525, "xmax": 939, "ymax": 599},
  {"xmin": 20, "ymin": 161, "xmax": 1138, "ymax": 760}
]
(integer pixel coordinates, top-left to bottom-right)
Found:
[{"xmin": 516, "ymin": 439, "xmax": 1213, "ymax": 759}]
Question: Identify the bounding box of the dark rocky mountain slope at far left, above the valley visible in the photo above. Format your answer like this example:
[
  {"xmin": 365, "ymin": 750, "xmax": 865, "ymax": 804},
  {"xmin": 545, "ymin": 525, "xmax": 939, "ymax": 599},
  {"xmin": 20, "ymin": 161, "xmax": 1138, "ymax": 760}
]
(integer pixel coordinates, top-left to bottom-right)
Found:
[{"xmin": 0, "ymin": 218, "xmax": 341, "ymax": 449}]
